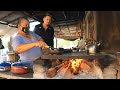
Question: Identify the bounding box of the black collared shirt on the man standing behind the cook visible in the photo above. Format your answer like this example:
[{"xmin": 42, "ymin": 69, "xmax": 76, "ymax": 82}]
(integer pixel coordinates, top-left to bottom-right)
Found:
[{"xmin": 34, "ymin": 24, "xmax": 54, "ymax": 47}]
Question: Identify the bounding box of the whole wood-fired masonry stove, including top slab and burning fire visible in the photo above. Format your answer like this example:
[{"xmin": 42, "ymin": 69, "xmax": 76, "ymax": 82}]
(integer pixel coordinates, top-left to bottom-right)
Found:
[{"xmin": 33, "ymin": 52, "xmax": 105, "ymax": 79}]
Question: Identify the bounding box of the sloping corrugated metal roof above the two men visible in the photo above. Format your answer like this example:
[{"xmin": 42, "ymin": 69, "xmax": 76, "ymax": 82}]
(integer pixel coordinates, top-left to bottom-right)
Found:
[{"xmin": 0, "ymin": 11, "xmax": 85, "ymax": 38}]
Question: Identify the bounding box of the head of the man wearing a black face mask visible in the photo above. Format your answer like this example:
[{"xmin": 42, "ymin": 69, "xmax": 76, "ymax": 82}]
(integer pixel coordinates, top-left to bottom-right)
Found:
[{"xmin": 18, "ymin": 17, "xmax": 29, "ymax": 34}]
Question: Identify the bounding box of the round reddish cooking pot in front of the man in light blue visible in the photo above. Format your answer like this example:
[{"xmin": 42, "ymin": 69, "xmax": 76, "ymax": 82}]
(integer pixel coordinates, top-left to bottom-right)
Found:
[{"xmin": 11, "ymin": 62, "xmax": 29, "ymax": 74}]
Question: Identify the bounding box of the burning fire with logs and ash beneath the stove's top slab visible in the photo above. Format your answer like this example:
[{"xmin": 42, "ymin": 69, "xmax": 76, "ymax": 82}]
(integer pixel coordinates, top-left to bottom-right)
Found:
[{"xmin": 46, "ymin": 59, "xmax": 102, "ymax": 79}]
